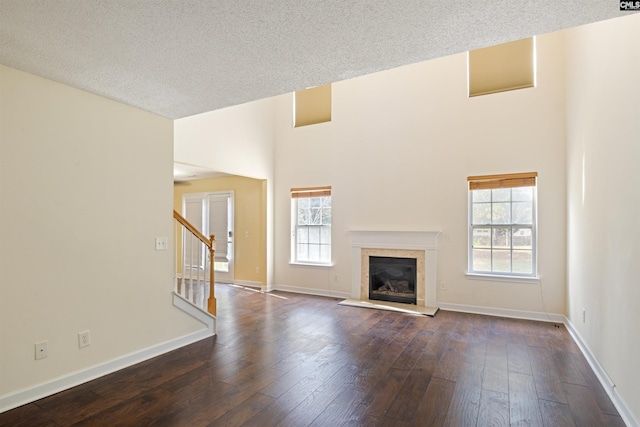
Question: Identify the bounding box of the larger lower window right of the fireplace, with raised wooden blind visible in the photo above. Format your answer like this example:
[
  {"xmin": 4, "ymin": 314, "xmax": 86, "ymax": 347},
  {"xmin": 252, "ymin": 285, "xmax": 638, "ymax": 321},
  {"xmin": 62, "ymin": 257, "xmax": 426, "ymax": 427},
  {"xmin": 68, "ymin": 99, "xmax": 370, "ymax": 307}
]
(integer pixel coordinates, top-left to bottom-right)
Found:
[{"xmin": 468, "ymin": 172, "xmax": 538, "ymax": 277}]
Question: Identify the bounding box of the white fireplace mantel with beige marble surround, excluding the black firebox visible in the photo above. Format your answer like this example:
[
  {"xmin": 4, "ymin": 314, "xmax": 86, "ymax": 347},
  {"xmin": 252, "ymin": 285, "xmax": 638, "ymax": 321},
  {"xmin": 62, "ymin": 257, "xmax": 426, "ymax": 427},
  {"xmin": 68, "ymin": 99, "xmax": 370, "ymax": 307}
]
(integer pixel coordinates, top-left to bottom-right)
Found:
[{"xmin": 349, "ymin": 230, "xmax": 440, "ymax": 307}]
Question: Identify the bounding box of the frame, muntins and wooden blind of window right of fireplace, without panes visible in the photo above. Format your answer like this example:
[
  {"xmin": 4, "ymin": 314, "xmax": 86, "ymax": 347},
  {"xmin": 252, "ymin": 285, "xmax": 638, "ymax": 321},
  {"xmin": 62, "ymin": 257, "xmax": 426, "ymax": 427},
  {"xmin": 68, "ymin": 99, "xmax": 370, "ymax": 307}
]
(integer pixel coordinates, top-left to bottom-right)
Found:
[{"xmin": 467, "ymin": 172, "xmax": 539, "ymax": 281}]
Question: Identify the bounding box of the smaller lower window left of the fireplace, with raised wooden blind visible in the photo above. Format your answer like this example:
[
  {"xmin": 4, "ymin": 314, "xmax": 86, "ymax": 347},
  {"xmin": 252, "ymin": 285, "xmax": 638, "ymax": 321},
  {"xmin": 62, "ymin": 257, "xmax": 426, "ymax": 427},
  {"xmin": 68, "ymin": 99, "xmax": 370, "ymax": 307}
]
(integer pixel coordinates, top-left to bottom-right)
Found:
[{"xmin": 291, "ymin": 187, "xmax": 331, "ymax": 265}]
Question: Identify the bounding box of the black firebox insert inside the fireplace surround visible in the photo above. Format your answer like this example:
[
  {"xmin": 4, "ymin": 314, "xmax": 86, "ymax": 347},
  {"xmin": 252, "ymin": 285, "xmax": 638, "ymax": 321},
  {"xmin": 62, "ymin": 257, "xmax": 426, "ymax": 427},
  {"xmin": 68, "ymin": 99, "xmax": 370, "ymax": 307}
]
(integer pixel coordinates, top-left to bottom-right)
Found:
[{"xmin": 369, "ymin": 256, "xmax": 417, "ymax": 304}]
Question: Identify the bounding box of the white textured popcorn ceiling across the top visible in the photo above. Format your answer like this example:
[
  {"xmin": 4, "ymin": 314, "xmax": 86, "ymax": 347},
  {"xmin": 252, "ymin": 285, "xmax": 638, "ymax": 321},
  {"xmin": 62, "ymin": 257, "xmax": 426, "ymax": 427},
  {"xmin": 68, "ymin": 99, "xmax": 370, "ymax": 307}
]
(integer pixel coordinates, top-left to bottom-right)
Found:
[{"xmin": 0, "ymin": 0, "xmax": 627, "ymax": 119}]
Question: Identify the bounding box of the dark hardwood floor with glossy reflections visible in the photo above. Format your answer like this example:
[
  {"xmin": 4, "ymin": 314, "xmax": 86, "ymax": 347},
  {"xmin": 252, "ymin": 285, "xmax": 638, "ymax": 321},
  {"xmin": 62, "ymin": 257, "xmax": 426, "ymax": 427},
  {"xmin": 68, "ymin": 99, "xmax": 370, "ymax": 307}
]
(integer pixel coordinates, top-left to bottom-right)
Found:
[{"xmin": 0, "ymin": 285, "xmax": 624, "ymax": 427}]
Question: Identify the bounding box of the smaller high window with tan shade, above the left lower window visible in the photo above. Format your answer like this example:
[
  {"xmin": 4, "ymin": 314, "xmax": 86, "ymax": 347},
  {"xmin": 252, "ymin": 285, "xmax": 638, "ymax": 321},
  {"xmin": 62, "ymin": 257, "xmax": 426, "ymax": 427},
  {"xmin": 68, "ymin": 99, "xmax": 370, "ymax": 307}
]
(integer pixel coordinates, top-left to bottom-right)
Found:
[{"xmin": 293, "ymin": 83, "xmax": 331, "ymax": 127}]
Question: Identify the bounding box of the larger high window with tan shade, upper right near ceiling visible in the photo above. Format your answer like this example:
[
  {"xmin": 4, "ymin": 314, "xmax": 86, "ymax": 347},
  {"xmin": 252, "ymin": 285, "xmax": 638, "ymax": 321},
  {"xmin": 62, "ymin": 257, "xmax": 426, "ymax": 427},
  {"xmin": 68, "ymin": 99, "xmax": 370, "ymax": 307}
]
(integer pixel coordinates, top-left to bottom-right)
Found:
[{"xmin": 468, "ymin": 37, "xmax": 536, "ymax": 96}]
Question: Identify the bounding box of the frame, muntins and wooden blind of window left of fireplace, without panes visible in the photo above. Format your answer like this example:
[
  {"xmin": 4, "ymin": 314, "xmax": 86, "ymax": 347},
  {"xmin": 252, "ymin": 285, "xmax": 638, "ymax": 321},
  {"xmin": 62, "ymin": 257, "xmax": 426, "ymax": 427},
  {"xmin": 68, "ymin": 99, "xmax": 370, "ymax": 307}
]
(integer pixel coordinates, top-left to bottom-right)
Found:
[{"xmin": 290, "ymin": 186, "xmax": 333, "ymax": 267}]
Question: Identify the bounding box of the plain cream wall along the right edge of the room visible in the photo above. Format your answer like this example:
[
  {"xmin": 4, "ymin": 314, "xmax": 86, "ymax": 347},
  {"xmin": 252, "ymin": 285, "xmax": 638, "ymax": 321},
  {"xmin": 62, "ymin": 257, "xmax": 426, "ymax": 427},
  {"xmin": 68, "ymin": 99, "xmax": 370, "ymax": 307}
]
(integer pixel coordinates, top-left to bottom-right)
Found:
[{"xmin": 567, "ymin": 14, "xmax": 640, "ymax": 424}]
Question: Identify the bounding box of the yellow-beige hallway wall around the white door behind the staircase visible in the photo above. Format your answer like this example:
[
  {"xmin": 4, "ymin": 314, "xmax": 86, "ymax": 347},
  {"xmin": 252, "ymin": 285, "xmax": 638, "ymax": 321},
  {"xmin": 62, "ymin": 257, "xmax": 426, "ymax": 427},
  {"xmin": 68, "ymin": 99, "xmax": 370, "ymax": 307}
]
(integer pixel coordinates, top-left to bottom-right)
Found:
[{"xmin": 173, "ymin": 176, "xmax": 267, "ymax": 286}]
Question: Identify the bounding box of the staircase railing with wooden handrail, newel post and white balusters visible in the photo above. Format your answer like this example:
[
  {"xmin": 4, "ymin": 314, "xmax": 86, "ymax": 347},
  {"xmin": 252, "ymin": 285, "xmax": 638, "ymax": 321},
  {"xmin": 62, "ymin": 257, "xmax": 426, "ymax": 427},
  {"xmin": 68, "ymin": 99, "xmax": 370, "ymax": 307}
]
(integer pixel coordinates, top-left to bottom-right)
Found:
[{"xmin": 173, "ymin": 210, "xmax": 217, "ymax": 316}]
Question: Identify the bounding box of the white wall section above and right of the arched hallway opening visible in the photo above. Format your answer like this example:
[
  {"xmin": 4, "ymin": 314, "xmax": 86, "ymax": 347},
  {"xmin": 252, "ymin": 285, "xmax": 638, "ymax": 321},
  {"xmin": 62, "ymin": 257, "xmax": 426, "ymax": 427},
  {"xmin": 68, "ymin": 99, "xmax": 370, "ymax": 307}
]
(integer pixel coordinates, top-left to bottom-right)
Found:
[{"xmin": 174, "ymin": 98, "xmax": 274, "ymax": 287}]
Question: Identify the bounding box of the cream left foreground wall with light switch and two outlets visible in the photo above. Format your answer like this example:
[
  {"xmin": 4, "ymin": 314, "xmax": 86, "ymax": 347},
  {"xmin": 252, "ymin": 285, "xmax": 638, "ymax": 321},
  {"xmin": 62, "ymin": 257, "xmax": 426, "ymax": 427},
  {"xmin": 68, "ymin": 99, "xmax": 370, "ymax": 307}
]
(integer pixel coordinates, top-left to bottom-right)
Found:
[{"xmin": 0, "ymin": 66, "xmax": 203, "ymax": 406}]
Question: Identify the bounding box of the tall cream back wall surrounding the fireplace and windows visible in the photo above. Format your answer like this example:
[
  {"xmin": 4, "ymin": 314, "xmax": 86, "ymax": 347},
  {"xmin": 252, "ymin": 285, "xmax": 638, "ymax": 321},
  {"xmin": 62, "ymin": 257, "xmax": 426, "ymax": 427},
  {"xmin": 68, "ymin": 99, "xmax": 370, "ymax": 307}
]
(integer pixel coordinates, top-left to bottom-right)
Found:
[{"xmin": 275, "ymin": 30, "xmax": 565, "ymax": 313}]
